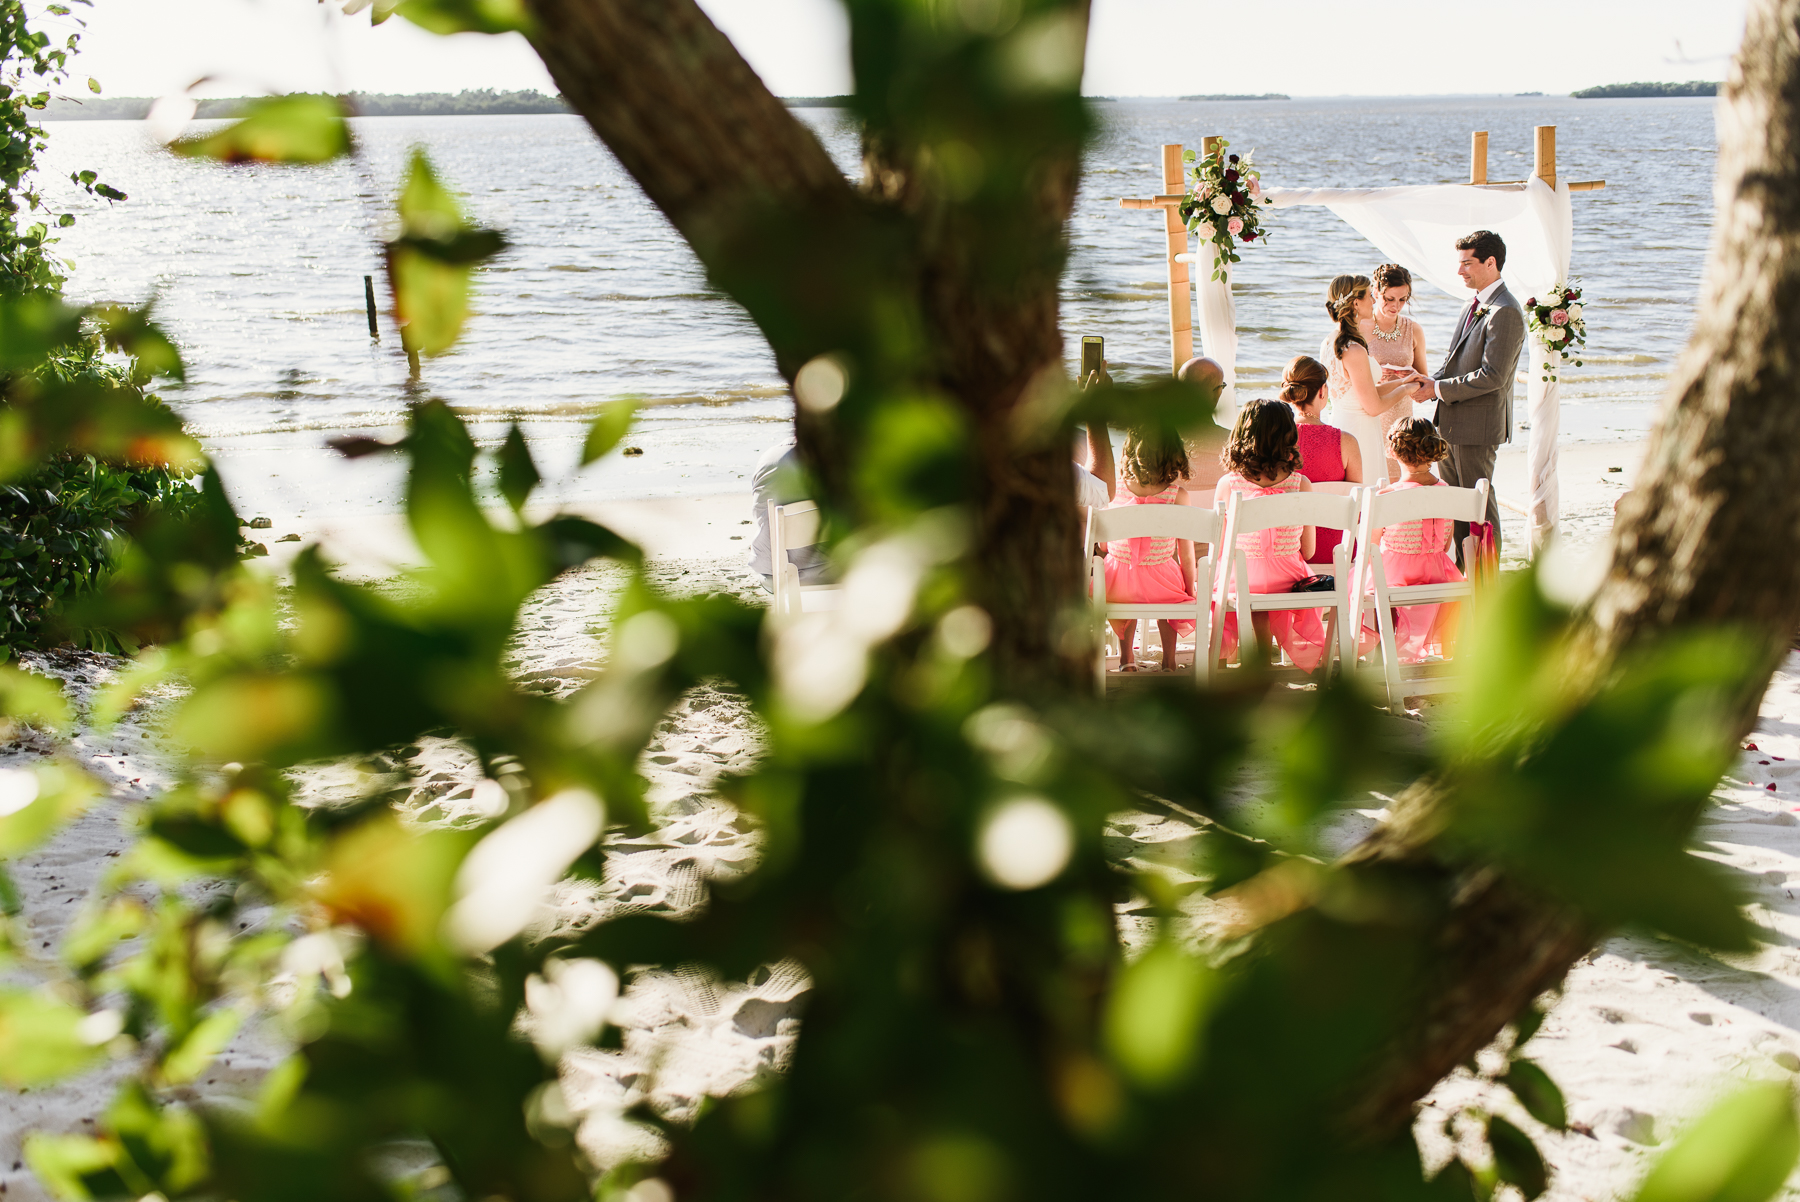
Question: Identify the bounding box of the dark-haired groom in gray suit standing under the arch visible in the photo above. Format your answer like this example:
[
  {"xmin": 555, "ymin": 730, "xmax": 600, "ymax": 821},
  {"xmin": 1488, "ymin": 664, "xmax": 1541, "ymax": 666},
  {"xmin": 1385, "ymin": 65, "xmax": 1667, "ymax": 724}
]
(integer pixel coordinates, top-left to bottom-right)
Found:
[{"xmin": 1413, "ymin": 230, "xmax": 1525, "ymax": 563}]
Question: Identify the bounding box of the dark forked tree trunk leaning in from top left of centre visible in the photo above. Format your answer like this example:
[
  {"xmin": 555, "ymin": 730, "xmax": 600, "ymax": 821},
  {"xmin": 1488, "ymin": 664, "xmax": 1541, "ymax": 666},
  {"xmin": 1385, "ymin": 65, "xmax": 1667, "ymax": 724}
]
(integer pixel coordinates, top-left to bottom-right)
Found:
[{"xmin": 531, "ymin": 0, "xmax": 1085, "ymax": 691}]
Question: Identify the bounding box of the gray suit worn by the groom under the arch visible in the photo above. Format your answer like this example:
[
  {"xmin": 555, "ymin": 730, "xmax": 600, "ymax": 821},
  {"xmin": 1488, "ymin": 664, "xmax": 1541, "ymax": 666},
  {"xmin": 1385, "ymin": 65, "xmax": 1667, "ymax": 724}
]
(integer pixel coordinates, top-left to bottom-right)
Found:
[{"xmin": 1431, "ymin": 284, "xmax": 1525, "ymax": 561}]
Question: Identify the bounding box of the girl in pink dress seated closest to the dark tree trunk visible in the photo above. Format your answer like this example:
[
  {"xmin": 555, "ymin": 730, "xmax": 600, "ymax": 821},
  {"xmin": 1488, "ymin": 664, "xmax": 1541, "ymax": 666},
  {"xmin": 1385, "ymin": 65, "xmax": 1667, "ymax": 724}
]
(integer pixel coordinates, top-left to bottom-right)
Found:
[{"xmin": 1105, "ymin": 430, "xmax": 1201, "ymax": 671}]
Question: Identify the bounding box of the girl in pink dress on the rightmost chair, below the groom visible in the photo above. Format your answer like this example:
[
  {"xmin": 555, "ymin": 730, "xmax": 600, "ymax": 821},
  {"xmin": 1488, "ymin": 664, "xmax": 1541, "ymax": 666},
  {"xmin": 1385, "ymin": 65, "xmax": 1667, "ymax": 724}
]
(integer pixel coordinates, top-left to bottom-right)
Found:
[{"xmin": 1364, "ymin": 417, "xmax": 1463, "ymax": 664}]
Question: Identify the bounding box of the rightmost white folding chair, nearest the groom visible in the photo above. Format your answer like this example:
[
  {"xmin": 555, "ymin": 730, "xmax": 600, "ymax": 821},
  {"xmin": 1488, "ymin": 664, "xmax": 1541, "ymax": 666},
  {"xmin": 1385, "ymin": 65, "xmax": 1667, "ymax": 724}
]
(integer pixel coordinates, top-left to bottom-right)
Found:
[{"xmin": 1355, "ymin": 480, "xmax": 1490, "ymax": 714}]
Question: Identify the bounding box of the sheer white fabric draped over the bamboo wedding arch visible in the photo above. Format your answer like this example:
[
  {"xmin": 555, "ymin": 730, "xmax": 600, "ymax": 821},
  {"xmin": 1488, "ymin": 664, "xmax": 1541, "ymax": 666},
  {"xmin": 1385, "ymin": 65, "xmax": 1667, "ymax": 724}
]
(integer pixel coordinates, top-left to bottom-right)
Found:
[{"xmin": 1199, "ymin": 176, "xmax": 1575, "ymax": 547}]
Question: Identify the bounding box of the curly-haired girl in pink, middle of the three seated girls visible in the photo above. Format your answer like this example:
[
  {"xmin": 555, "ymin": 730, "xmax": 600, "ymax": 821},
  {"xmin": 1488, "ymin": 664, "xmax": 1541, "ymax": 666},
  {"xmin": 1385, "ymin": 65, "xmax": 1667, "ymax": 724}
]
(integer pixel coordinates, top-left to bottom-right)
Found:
[{"xmin": 1213, "ymin": 399, "xmax": 1327, "ymax": 671}]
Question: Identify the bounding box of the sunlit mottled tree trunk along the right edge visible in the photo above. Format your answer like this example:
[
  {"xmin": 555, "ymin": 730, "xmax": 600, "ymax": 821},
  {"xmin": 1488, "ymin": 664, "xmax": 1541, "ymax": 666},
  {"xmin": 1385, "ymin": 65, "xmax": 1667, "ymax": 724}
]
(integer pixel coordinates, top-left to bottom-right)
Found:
[{"xmin": 1346, "ymin": 0, "xmax": 1800, "ymax": 1139}]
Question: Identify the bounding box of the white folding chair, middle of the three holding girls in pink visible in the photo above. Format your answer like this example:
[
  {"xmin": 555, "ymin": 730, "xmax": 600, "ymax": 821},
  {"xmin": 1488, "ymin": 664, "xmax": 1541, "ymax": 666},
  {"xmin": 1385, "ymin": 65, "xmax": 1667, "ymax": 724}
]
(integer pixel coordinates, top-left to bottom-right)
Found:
[{"xmin": 1211, "ymin": 493, "xmax": 1359, "ymax": 671}]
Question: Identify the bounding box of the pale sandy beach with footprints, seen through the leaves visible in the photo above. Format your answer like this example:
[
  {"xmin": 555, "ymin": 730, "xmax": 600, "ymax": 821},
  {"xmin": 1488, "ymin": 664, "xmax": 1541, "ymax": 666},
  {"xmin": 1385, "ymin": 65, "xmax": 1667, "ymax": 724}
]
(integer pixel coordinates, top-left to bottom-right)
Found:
[{"xmin": 0, "ymin": 424, "xmax": 1756, "ymax": 1202}]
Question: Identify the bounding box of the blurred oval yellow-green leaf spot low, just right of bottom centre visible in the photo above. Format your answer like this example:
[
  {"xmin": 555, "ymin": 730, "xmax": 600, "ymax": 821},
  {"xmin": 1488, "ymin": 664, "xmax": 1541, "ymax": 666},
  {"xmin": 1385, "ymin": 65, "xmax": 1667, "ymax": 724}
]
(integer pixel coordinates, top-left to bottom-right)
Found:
[{"xmin": 1105, "ymin": 939, "xmax": 1217, "ymax": 1089}]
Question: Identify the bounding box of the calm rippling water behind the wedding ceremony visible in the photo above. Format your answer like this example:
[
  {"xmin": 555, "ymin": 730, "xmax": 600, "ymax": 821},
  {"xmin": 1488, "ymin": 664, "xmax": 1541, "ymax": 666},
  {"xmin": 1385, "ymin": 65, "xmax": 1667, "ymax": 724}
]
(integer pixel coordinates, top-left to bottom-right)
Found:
[{"xmin": 47, "ymin": 97, "xmax": 1714, "ymax": 495}]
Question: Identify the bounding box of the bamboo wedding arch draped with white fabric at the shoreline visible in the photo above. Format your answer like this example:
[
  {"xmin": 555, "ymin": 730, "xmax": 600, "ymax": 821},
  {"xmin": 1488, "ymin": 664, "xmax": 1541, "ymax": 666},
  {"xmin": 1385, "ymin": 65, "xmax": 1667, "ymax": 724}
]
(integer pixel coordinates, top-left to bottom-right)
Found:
[{"xmin": 1120, "ymin": 126, "xmax": 1606, "ymax": 549}]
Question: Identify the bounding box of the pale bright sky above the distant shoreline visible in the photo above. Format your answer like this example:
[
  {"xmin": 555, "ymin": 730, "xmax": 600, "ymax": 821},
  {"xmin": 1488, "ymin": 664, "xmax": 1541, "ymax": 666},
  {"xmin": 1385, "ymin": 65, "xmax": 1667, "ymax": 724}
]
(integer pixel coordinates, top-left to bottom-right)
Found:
[{"xmin": 52, "ymin": 0, "xmax": 1748, "ymax": 95}]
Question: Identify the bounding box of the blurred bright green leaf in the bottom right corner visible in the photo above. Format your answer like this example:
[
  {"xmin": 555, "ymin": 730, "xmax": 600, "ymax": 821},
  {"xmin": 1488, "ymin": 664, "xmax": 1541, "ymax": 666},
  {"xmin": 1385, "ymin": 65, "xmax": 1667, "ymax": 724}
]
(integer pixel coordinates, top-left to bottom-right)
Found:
[{"xmin": 1636, "ymin": 1081, "xmax": 1800, "ymax": 1202}]
